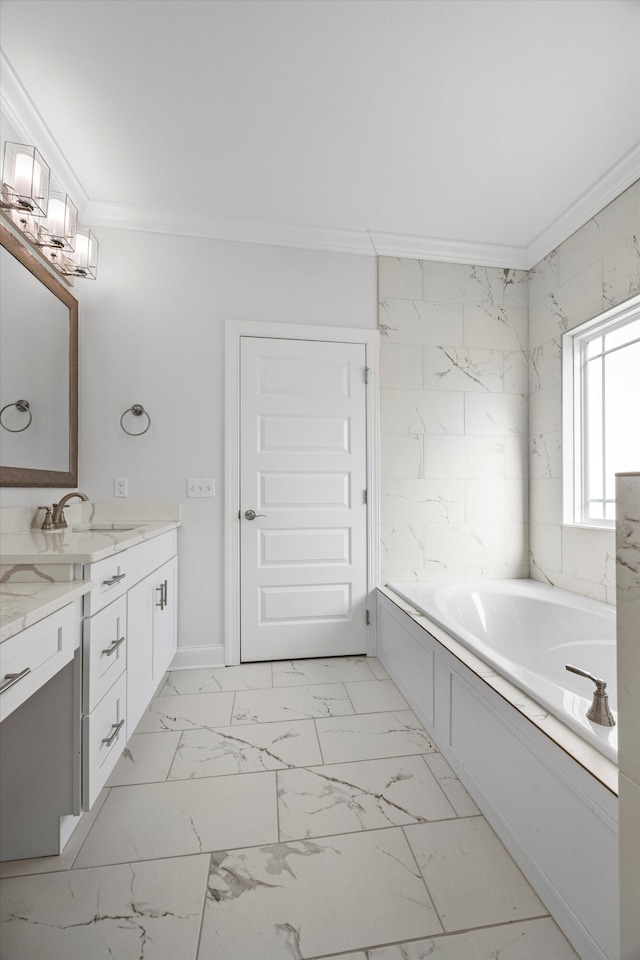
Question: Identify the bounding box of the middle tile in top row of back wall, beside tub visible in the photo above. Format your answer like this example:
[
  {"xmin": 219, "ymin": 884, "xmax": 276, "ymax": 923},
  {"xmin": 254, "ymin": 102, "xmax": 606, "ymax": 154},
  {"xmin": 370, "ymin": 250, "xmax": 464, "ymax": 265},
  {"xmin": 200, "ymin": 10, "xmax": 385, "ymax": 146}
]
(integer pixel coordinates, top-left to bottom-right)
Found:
[{"xmin": 422, "ymin": 260, "xmax": 511, "ymax": 306}]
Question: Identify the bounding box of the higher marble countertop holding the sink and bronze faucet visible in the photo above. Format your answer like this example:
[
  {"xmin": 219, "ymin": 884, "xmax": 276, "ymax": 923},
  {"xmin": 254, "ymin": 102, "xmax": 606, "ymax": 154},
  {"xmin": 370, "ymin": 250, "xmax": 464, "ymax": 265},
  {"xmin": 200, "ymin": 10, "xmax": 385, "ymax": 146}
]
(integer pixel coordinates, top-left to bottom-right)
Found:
[{"xmin": 0, "ymin": 520, "xmax": 180, "ymax": 567}]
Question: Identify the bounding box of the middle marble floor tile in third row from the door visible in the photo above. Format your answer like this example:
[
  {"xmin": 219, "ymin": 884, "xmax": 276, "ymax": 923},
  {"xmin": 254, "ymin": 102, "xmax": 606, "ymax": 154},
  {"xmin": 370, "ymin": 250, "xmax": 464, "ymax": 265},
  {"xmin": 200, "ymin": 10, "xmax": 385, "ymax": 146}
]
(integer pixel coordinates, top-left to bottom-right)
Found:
[{"xmin": 168, "ymin": 720, "xmax": 322, "ymax": 780}]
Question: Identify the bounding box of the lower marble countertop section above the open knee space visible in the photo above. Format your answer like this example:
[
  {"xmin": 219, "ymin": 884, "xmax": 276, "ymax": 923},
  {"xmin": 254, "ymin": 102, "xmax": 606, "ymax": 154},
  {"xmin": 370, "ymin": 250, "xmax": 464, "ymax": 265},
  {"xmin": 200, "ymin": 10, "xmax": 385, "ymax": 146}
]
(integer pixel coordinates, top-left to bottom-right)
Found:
[{"xmin": 0, "ymin": 580, "xmax": 93, "ymax": 643}]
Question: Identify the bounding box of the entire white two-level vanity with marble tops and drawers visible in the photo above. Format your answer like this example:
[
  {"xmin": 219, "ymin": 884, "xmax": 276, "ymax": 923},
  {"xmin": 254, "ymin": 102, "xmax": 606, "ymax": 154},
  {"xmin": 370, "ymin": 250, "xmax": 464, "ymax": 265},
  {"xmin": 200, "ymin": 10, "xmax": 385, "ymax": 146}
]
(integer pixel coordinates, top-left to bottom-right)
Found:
[{"xmin": 0, "ymin": 504, "xmax": 180, "ymax": 860}]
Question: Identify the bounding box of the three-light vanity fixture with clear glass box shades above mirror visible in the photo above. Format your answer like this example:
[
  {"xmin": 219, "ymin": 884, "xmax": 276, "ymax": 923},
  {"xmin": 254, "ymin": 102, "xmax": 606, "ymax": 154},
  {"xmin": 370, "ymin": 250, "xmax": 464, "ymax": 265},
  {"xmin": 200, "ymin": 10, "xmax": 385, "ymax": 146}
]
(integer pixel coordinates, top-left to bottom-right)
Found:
[{"xmin": 0, "ymin": 143, "xmax": 98, "ymax": 280}]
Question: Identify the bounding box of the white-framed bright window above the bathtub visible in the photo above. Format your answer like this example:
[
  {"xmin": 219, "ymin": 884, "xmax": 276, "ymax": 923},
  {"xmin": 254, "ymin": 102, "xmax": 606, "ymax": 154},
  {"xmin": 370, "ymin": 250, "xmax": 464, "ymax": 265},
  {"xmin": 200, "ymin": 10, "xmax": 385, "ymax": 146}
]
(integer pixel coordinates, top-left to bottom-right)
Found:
[{"xmin": 562, "ymin": 296, "xmax": 640, "ymax": 527}]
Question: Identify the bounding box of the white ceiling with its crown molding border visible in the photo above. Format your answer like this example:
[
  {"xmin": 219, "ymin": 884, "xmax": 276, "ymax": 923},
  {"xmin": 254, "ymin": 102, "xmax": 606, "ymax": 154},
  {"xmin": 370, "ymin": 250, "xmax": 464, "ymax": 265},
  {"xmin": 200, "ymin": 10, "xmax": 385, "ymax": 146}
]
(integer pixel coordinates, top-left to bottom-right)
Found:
[{"xmin": 0, "ymin": 0, "xmax": 640, "ymax": 265}]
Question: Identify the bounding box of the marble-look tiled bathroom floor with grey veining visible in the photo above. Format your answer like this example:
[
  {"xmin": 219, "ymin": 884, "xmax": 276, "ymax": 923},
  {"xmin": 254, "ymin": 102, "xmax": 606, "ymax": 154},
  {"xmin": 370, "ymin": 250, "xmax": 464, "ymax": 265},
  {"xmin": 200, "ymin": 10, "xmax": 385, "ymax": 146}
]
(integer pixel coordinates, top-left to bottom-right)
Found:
[{"xmin": 0, "ymin": 657, "xmax": 576, "ymax": 960}]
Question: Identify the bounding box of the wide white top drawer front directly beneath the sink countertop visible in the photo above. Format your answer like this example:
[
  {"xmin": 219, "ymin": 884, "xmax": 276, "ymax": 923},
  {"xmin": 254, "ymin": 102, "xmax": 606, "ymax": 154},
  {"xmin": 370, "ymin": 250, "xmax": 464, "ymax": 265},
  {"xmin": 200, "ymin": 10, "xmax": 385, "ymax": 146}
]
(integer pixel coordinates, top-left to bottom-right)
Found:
[{"xmin": 84, "ymin": 530, "xmax": 178, "ymax": 616}]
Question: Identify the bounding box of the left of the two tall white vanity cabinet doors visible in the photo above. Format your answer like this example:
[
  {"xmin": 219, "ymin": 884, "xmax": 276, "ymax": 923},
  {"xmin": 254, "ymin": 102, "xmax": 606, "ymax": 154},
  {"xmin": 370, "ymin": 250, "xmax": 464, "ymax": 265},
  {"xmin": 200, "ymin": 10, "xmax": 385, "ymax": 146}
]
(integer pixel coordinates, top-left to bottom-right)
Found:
[{"xmin": 127, "ymin": 571, "xmax": 158, "ymax": 733}]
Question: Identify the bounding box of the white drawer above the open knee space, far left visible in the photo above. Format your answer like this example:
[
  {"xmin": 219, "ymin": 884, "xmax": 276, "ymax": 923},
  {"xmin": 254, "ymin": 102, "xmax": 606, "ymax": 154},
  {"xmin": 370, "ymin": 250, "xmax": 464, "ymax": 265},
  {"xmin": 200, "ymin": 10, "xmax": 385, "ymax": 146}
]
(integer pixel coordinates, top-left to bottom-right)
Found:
[{"xmin": 0, "ymin": 601, "xmax": 80, "ymax": 721}]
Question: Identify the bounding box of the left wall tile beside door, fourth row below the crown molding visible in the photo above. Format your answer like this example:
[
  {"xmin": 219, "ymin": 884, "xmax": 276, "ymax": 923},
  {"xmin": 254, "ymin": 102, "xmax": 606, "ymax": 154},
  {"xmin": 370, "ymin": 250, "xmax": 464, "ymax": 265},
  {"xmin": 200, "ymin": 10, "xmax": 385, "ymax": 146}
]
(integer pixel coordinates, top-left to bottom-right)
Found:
[{"xmin": 380, "ymin": 390, "xmax": 464, "ymax": 436}]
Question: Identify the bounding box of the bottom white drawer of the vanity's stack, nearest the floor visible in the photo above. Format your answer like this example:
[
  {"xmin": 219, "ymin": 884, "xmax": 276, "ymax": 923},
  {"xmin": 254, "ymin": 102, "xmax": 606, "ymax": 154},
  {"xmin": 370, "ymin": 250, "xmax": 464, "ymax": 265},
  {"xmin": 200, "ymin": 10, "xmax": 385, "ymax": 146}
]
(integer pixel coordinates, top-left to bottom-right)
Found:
[{"xmin": 82, "ymin": 673, "xmax": 127, "ymax": 810}]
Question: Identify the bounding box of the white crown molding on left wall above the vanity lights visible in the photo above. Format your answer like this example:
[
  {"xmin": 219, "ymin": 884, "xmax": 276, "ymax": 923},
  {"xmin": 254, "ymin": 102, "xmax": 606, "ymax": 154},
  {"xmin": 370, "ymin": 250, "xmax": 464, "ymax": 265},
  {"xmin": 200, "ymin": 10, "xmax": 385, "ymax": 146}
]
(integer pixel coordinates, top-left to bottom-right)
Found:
[{"xmin": 0, "ymin": 49, "xmax": 89, "ymax": 218}]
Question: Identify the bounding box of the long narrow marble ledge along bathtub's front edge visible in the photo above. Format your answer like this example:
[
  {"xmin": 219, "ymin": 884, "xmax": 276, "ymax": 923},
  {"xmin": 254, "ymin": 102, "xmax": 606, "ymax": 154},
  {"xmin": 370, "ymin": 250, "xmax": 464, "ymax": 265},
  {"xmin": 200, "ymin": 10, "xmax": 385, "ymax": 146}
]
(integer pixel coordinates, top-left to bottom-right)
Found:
[{"xmin": 378, "ymin": 587, "xmax": 618, "ymax": 795}]
